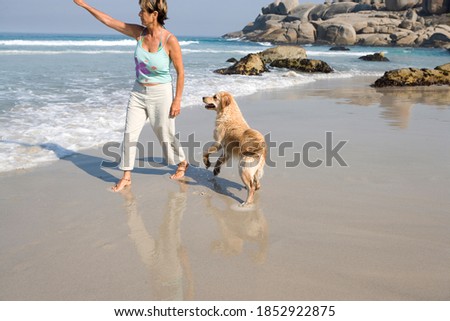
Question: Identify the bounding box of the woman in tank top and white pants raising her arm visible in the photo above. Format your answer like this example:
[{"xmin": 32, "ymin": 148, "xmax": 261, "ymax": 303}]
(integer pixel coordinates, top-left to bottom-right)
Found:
[{"xmin": 74, "ymin": 0, "xmax": 189, "ymax": 192}]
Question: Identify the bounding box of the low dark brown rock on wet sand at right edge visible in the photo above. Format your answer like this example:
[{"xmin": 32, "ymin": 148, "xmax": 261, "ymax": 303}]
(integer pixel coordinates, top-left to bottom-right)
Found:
[{"xmin": 373, "ymin": 63, "xmax": 450, "ymax": 87}]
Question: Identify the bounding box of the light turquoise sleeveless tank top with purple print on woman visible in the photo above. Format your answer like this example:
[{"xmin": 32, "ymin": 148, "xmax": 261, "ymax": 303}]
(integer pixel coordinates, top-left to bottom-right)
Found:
[{"xmin": 134, "ymin": 29, "xmax": 172, "ymax": 84}]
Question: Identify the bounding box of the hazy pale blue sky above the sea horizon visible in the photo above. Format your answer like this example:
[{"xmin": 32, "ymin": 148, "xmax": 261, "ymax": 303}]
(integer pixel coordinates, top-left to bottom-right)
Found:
[{"xmin": 0, "ymin": 0, "xmax": 323, "ymax": 36}]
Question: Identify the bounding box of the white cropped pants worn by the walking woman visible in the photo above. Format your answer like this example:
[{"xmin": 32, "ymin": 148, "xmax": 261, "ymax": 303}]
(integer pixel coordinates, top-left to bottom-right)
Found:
[{"xmin": 119, "ymin": 82, "xmax": 186, "ymax": 170}]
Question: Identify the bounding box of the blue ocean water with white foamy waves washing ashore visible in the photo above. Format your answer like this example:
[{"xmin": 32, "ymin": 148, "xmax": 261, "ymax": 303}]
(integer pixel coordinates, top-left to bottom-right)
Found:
[{"xmin": 0, "ymin": 34, "xmax": 450, "ymax": 172}]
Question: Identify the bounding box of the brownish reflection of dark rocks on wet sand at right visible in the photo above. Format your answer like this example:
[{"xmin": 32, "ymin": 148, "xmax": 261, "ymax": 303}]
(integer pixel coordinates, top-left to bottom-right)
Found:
[{"xmin": 308, "ymin": 86, "xmax": 450, "ymax": 129}]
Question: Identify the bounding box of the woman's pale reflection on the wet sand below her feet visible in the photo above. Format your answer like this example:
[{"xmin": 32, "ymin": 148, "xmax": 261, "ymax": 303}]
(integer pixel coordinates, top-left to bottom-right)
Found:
[{"xmin": 121, "ymin": 182, "xmax": 194, "ymax": 301}]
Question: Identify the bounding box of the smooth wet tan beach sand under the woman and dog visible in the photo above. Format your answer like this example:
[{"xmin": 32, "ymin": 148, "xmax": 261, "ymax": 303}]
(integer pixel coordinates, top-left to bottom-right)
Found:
[{"xmin": 0, "ymin": 78, "xmax": 450, "ymax": 300}]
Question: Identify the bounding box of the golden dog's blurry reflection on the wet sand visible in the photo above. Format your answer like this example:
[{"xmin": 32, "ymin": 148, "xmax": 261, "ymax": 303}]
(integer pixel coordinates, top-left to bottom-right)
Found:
[{"xmin": 206, "ymin": 192, "xmax": 269, "ymax": 264}]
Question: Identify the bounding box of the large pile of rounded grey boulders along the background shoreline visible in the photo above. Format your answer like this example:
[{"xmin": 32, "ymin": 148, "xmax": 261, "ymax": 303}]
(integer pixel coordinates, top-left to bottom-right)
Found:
[{"xmin": 224, "ymin": 0, "xmax": 450, "ymax": 48}]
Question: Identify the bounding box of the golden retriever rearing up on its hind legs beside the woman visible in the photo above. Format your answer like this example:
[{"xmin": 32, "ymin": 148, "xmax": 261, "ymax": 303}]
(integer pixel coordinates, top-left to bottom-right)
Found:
[{"xmin": 203, "ymin": 91, "xmax": 266, "ymax": 206}]
